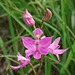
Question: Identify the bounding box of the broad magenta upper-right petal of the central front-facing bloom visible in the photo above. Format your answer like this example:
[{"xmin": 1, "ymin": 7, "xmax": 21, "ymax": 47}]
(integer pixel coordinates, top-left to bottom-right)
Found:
[{"xmin": 39, "ymin": 36, "xmax": 53, "ymax": 48}]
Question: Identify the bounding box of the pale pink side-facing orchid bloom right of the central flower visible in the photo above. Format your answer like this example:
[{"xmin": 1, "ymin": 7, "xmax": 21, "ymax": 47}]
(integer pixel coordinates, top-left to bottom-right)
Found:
[{"xmin": 48, "ymin": 37, "xmax": 68, "ymax": 61}]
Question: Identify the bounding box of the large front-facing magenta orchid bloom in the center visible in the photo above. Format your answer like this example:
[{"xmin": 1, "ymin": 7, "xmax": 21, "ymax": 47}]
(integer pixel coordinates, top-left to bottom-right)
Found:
[{"xmin": 21, "ymin": 28, "xmax": 53, "ymax": 59}]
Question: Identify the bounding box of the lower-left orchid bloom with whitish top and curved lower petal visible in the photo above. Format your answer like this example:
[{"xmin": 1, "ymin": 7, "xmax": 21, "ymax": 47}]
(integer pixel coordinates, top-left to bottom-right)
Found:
[{"xmin": 10, "ymin": 52, "xmax": 30, "ymax": 70}]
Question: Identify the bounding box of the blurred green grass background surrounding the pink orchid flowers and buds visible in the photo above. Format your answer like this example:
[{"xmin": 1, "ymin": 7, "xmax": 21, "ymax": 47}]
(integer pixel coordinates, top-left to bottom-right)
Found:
[{"xmin": 0, "ymin": 0, "xmax": 75, "ymax": 75}]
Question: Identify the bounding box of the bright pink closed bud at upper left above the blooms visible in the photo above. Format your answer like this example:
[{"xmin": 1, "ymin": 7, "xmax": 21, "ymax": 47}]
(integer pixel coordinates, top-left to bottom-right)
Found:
[{"xmin": 23, "ymin": 9, "xmax": 35, "ymax": 26}]
